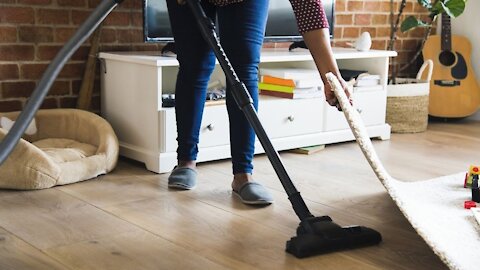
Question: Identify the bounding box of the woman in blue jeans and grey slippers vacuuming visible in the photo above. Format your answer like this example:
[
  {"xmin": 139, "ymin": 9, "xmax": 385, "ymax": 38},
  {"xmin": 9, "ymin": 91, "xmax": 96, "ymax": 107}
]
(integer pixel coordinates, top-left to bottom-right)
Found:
[{"xmin": 166, "ymin": 0, "xmax": 348, "ymax": 204}]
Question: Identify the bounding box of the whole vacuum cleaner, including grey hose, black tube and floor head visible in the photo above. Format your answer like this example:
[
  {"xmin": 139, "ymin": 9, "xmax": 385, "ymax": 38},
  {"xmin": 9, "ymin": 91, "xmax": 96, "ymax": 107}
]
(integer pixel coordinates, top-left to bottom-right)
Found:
[{"xmin": 0, "ymin": 0, "xmax": 382, "ymax": 258}]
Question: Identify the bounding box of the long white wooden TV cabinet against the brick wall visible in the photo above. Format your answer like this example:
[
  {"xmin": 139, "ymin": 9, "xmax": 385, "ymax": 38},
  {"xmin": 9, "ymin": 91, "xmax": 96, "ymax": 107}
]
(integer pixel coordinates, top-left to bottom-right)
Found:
[{"xmin": 99, "ymin": 48, "xmax": 396, "ymax": 173}]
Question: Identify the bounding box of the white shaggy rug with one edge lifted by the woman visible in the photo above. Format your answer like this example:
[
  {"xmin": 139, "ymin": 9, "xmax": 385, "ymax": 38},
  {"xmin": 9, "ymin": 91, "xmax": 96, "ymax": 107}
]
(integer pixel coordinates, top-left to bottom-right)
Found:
[{"xmin": 327, "ymin": 73, "xmax": 480, "ymax": 270}]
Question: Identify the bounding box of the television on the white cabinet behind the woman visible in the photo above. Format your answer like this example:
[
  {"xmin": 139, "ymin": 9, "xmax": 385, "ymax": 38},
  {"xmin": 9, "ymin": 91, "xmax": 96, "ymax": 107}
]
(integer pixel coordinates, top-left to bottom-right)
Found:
[{"xmin": 143, "ymin": 0, "xmax": 335, "ymax": 43}]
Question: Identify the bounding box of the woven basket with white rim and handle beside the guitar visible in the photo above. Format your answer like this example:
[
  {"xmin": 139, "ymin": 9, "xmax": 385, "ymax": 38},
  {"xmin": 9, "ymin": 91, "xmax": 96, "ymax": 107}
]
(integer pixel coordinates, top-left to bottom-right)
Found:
[{"xmin": 386, "ymin": 60, "xmax": 433, "ymax": 133}]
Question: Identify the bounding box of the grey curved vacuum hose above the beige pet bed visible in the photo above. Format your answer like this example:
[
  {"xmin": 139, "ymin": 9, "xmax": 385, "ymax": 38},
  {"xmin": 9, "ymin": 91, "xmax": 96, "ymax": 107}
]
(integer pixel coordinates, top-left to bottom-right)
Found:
[{"xmin": 0, "ymin": 0, "xmax": 123, "ymax": 165}]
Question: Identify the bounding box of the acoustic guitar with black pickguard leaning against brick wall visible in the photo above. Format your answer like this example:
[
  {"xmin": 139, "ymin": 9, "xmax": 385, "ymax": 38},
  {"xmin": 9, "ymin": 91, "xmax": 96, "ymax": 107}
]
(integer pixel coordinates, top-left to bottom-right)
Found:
[{"xmin": 422, "ymin": 14, "xmax": 480, "ymax": 118}]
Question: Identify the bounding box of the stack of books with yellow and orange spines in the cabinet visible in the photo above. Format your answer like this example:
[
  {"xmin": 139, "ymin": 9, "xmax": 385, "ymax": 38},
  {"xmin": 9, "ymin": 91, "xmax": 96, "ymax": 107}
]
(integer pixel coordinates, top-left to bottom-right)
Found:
[{"xmin": 258, "ymin": 68, "xmax": 323, "ymax": 99}]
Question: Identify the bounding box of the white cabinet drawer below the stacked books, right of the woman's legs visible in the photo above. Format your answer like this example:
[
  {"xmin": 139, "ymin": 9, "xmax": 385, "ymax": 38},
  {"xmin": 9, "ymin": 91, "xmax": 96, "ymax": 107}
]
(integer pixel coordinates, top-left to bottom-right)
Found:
[{"xmin": 258, "ymin": 97, "xmax": 324, "ymax": 138}]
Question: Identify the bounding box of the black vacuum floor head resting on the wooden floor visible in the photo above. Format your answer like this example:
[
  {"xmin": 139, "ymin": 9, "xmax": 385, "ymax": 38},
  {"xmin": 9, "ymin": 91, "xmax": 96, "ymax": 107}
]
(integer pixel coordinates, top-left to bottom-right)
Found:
[{"xmin": 286, "ymin": 216, "xmax": 382, "ymax": 258}]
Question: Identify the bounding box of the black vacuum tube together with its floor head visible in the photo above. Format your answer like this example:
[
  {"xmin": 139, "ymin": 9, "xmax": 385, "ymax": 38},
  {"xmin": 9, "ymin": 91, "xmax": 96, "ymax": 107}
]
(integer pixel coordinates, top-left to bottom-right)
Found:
[{"xmin": 186, "ymin": 0, "xmax": 382, "ymax": 258}]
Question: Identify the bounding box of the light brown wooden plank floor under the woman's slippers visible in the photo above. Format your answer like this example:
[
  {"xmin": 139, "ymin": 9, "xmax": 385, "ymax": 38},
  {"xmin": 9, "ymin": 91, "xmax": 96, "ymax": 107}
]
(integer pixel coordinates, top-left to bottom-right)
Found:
[{"xmin": 0, "ymin": 120, "xmax": 480, "ymax": 270}]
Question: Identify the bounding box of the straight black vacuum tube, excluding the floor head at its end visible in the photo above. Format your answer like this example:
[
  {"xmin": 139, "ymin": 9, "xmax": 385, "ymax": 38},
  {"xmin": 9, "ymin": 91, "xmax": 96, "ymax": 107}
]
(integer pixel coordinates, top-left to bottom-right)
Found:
[{"xmin": 186, "ymin": 0, "xmax": 312, "ymax": 220}]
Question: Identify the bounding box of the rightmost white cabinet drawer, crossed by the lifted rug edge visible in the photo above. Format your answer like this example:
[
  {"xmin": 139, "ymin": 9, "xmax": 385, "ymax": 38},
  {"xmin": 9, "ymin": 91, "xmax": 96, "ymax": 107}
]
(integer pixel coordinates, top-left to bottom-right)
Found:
[{"xmin": 323, "ymin": 91, "xmax": 387, "ymax": 131}]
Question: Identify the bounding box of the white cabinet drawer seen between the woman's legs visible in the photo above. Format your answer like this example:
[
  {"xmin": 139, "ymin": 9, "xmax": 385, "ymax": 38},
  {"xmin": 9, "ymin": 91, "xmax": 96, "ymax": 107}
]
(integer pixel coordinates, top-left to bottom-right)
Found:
[{"xmin": 198, "ymin": 105, "xmax": 230, "ymax": 147}]
